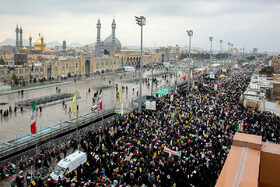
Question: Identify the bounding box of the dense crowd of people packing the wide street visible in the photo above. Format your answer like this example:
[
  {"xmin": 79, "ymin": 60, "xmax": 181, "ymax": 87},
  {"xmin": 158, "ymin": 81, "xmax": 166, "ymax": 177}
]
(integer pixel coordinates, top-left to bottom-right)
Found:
[{"xmin": 5, "ymin": 65, "xmax": 280, "ymax": 187}]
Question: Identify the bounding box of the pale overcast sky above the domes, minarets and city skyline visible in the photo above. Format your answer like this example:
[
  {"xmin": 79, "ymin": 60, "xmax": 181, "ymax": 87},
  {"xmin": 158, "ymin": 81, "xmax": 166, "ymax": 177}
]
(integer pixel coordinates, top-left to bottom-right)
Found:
[{"xmin": 0, "ymin": 0, "xmax": 280, "ymax": 52}]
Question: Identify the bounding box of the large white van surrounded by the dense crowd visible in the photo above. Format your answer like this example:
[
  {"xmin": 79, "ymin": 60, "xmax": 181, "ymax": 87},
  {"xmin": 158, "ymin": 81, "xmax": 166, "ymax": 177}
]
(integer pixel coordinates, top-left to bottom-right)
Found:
[{"xmin": 50, "ymin": 151, "xmax": 87, "ymax": 180}]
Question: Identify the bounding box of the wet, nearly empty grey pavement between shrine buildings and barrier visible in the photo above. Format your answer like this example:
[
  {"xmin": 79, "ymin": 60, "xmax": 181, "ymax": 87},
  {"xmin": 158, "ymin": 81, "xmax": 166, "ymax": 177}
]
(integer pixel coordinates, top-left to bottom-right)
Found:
[{"xmin": 0, "ymin": 70, "xmax": 186, "ymax": 142}]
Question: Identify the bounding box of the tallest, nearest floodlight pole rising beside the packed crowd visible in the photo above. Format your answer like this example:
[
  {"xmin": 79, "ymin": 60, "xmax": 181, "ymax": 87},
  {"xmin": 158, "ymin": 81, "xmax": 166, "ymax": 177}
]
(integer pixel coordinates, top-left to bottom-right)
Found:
[{"xmin": 135, "ymin": 16, "xmax": 146, "ymax": 113}]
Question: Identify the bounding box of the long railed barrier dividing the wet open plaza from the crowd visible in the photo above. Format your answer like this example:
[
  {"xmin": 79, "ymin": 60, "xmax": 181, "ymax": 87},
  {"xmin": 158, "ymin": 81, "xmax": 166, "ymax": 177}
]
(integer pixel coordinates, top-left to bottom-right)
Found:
[{"xmin": 0, "ymin": 109, "xmax": 118, "ymax": 165}]
